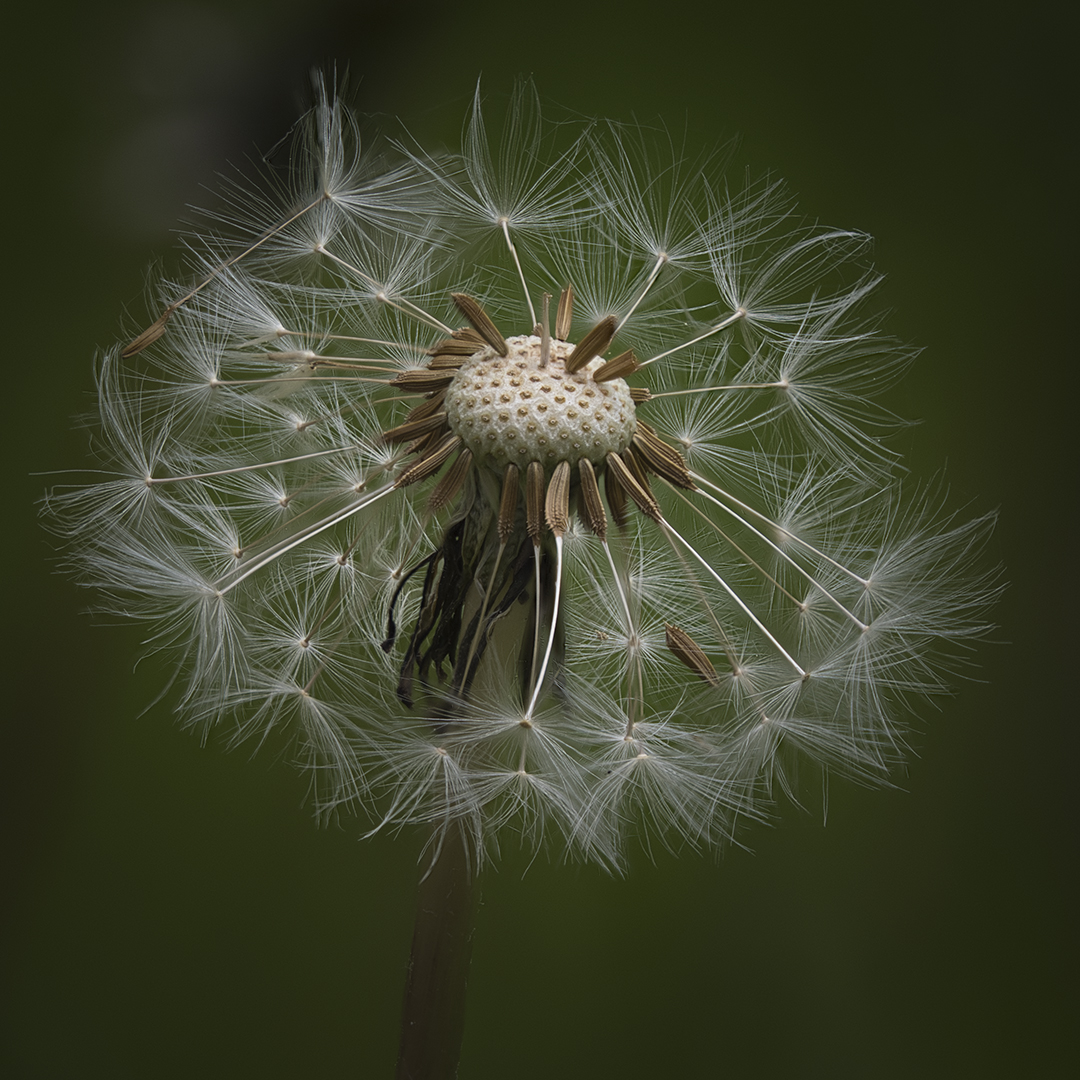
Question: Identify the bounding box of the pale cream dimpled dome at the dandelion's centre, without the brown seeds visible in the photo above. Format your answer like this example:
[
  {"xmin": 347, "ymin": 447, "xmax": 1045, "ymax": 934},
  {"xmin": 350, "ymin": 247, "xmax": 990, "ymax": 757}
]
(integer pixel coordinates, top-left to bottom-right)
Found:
[{"xmin": 445, "ymin": 336, "xmax": 637, "ymax": 471}]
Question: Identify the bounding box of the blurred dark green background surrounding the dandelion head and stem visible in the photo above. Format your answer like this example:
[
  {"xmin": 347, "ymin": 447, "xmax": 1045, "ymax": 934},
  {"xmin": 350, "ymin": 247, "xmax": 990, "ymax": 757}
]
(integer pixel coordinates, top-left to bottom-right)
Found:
[{"xmin": 6, "ymin": 0, "xmax": 1078, "ymax": 1080}]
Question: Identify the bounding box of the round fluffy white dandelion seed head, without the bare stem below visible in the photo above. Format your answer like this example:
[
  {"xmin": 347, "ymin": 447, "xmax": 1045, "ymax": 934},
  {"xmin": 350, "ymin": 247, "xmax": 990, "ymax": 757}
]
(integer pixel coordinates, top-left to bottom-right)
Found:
[{"xmin": 50, "ymin": 73, "xmax": 994, "ymax": 1071}]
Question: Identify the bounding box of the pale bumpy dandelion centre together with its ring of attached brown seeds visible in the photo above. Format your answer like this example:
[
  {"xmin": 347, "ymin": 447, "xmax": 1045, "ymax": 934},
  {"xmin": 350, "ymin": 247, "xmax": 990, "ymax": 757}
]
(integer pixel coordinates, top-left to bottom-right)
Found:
[{"xmin": 382, "ymin": 287, "xmax": 694, "ymax": 542}]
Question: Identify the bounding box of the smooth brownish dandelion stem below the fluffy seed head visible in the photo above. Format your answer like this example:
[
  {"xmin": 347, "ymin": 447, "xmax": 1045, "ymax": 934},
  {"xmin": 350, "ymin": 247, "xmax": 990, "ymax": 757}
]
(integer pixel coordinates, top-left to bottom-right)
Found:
[{"xmin": 397, "ymin": 825, "xmax": 474, "ymax": 1080}]
